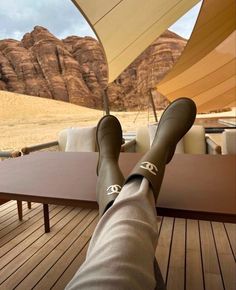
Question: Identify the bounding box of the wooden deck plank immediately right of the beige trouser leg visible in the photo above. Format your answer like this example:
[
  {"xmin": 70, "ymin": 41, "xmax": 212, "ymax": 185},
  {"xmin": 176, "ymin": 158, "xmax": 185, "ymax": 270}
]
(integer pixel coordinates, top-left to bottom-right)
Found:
[{"xmin": 155, "ymin": 217, "xmax": 174, "ymax": 281}]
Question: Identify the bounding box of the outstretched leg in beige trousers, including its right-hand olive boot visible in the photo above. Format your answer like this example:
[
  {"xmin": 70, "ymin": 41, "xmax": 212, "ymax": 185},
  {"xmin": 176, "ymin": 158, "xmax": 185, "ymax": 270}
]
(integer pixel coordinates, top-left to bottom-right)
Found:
[{"xmin": 67, "ymin": 99, "xmax": 196, "ymax": 289}]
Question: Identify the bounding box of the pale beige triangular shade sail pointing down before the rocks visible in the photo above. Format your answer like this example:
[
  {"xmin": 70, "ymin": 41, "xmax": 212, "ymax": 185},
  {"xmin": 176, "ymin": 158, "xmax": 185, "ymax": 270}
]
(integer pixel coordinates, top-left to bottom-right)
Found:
[{"xmin": 72, "ymin": 0, "xmax": 199, "ymax": 82}]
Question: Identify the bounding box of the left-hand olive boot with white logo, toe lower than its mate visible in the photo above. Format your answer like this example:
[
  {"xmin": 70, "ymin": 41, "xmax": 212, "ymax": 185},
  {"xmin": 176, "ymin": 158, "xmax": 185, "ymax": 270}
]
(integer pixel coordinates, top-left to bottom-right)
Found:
[{"xmin": 96, "ymin": 115, "xmax": 124, "ymax": 216}]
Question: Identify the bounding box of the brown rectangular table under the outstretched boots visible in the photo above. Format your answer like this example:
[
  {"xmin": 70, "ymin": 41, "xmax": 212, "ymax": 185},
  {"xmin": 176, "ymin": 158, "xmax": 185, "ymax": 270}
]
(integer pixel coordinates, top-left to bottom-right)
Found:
[{"xmin": 0, "ymin": 152, "xmax": 236, "ymax": 232}]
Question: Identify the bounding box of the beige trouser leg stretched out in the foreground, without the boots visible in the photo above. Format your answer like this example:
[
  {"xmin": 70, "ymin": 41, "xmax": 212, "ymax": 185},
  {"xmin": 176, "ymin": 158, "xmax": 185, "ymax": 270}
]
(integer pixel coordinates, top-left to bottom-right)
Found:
[{"xmin": 66, "ymin": 177, "xmax": 158, "ymax": 290}]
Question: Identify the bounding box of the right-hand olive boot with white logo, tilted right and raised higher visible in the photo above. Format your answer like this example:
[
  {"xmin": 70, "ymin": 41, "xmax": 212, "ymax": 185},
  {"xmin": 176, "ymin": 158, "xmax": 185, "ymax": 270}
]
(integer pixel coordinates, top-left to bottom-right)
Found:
[{"xmin": 126, "ymin": 98, "xmax": 196, "ymax": 200}]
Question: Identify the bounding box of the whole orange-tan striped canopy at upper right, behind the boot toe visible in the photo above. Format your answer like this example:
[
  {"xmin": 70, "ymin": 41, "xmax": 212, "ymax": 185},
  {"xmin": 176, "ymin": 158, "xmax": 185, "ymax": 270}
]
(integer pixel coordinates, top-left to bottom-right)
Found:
[{"xmin": 157, "ymin": 0, "xmax": 236, "ymax": 112}]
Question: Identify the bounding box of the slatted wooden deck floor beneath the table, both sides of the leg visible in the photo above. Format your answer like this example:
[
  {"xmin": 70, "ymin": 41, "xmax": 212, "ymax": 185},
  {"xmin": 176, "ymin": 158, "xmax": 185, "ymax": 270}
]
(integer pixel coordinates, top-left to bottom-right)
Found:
[{"xmin": 0, "ymin": 201, "xmax": 236, "ymax": 290}]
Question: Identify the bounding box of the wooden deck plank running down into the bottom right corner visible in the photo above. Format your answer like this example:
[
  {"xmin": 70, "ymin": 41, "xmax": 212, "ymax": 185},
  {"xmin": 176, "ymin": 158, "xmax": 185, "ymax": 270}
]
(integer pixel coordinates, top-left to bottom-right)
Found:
[{"xmin": 212, "ymin": 222, "xmax": 236, "ymax": 290}]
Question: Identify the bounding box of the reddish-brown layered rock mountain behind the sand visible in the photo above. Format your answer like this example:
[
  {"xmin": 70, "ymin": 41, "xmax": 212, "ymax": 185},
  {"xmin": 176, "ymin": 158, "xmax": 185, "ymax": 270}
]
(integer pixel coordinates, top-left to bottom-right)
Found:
[{"xmin": 0, "ymin": 26, "xmax": 186, "ymax": 110}]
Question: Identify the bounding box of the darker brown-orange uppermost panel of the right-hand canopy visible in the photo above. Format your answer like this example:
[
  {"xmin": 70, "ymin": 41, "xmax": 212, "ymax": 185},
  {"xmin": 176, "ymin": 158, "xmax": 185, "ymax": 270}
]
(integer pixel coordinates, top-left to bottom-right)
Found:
[{"xmin": 161, "ymin": 0, "xmax": 236, "ymax": 83}]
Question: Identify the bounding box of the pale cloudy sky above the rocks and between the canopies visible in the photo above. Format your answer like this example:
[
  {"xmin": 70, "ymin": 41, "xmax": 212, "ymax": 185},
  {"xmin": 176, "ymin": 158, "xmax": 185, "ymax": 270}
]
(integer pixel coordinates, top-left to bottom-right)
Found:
[{"xmin": 0, "ymin": 0, "xmax": 201, "ymax": 40}]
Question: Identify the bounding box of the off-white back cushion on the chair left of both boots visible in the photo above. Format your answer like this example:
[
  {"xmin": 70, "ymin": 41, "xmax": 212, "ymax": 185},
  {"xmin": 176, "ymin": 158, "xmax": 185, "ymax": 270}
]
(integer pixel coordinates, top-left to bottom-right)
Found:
[{"xmin": 59, "ymin": 127, "xmax": 96, "ymax": 152}]
